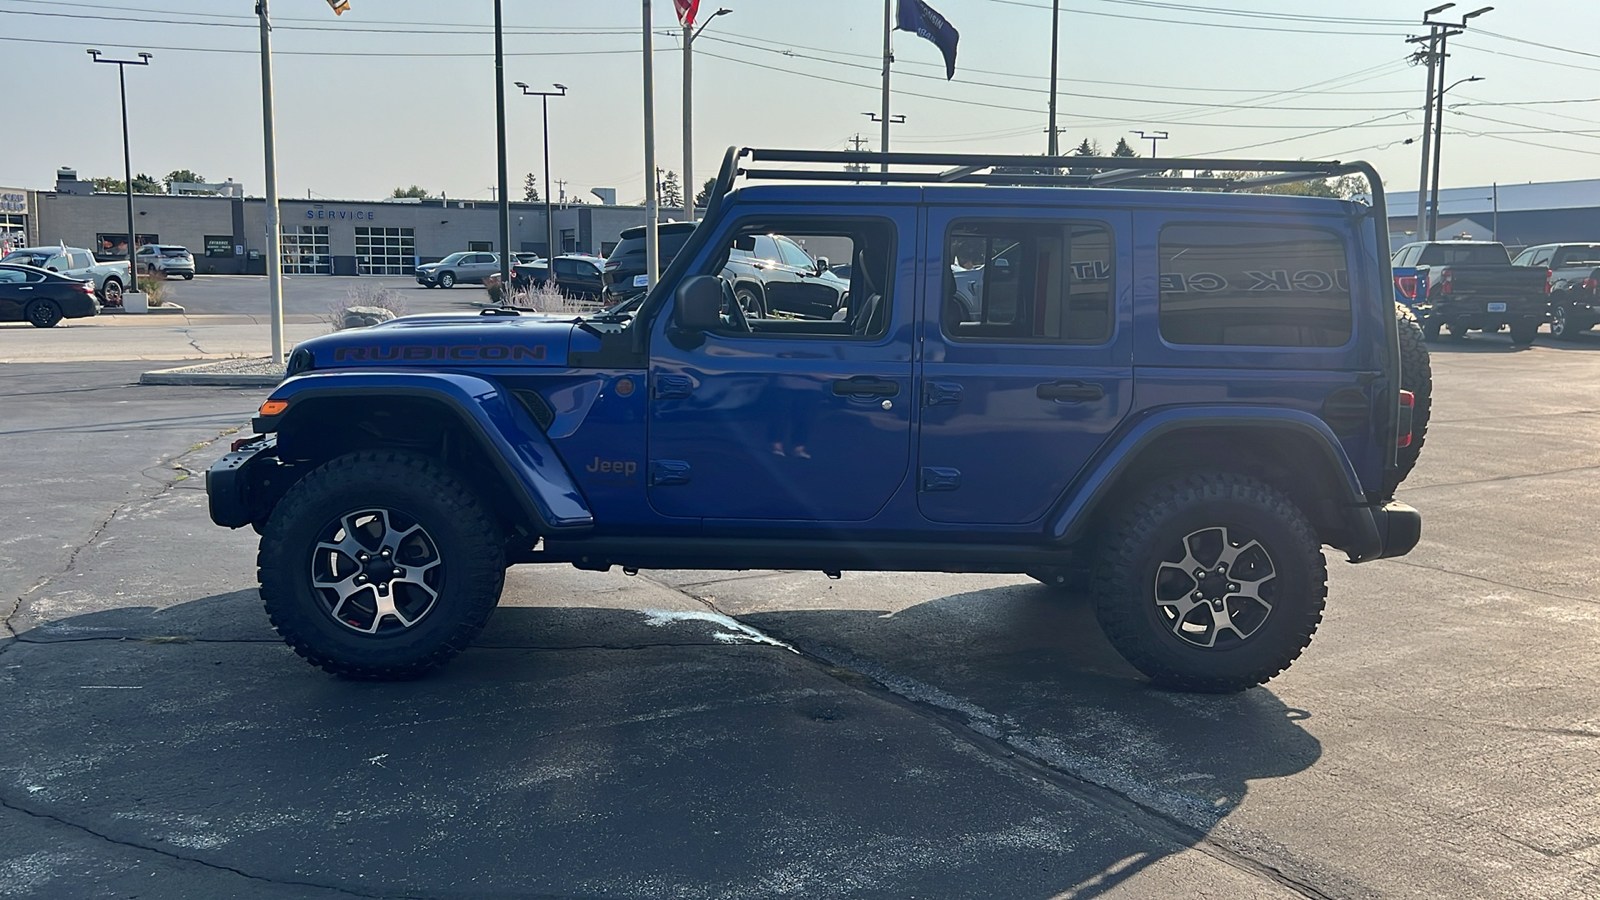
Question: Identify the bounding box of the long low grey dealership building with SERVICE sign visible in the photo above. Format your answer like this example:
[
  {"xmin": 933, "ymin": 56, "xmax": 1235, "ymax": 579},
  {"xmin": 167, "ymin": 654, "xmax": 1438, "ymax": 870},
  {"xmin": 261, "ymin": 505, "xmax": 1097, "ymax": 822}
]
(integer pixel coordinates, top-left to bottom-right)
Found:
[{"xmin": 15, "ymin": 170, "xmax": 645, "ymax": 275}]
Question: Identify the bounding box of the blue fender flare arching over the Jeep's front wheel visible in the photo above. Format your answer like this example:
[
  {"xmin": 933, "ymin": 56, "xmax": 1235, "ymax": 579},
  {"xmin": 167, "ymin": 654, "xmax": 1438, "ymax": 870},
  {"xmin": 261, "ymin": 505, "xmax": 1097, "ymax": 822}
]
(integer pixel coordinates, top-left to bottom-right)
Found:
[{"xmin": 253, "ymin": 370, "xmax": 594, "ymax": 535}]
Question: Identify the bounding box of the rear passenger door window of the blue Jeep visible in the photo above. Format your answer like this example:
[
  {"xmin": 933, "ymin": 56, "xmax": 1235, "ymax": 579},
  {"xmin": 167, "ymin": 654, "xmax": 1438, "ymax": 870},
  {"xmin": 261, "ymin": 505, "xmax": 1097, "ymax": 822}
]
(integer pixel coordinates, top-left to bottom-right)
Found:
[{"xmin": 942, "ymin": 219, "xmax": 1112, "ymax": 344}]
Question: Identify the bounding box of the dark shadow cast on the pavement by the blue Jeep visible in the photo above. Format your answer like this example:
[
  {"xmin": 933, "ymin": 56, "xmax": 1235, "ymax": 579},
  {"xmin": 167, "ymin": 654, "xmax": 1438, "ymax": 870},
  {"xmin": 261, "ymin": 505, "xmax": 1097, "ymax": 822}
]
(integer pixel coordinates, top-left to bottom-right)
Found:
[{"xmin": 0, "ymin": 586, "xmax": 1320, "ymax": 898}]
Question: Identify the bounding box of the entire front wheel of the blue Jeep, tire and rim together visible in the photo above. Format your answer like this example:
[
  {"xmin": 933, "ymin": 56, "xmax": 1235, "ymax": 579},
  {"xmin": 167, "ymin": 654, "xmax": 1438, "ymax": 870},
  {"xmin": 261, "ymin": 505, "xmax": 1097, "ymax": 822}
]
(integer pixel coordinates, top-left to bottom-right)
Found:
[{"xmin": 258, "ymin": 452, "xmax": 506, "ymax": 679}]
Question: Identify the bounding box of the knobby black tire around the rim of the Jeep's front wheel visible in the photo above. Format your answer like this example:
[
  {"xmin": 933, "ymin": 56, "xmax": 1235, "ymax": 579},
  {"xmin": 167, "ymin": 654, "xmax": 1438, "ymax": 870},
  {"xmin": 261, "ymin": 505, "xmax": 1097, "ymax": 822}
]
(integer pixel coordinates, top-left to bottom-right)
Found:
[{"xmin": 256, "ymin": 450, "xmax": 506, "ymax": 681}]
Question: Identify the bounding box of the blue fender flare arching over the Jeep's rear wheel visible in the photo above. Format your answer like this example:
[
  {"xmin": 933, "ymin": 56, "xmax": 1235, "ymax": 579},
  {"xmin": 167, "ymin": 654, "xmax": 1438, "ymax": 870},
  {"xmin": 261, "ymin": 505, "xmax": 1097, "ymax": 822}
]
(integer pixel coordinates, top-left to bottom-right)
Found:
[{"xmin": 1048, "ymin": 407, "xmax": 1378, "ymax": 549}]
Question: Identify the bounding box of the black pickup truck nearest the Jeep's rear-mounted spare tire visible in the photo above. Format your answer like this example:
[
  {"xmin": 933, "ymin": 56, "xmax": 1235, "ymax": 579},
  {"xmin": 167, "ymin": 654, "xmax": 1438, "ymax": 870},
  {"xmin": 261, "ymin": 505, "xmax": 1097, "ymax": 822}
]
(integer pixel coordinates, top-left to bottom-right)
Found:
[{"xmin": 1394, "ymin": 240, "xmax": 1549, "ymax": 344}]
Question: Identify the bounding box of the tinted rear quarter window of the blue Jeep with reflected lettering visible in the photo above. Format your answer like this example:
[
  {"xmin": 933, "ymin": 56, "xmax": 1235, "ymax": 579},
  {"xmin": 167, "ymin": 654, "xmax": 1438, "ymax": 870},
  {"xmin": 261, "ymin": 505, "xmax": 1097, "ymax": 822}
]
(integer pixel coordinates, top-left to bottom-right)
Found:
[{"xmin": 1160, "ymin": 223, "xmax": 1352, "ymax": 348}]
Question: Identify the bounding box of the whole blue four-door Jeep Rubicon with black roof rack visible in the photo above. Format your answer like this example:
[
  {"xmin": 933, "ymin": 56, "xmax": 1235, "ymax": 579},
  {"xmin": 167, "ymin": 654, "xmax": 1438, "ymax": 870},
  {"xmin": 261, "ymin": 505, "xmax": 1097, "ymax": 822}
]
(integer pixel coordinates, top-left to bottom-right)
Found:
[{"xmin": 206, "ymin": 149, "xmax": 1426, "ymax": 692}]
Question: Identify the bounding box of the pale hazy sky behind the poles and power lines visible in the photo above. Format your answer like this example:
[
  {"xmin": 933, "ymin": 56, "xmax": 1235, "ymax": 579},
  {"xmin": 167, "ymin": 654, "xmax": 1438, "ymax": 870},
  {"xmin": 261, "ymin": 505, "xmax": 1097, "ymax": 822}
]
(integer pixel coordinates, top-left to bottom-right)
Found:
[{"xmin": 0, "ymin": 0, "xmax": 1600, "ymax": 203}]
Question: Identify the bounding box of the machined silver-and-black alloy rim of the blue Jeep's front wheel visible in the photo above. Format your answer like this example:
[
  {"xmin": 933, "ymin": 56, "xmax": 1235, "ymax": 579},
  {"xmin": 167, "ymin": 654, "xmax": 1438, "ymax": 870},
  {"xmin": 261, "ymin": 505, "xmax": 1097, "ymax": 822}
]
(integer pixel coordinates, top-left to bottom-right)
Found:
[{"xmin": 310, "ymin": 509, "xmax": 445, "ymax": 634}]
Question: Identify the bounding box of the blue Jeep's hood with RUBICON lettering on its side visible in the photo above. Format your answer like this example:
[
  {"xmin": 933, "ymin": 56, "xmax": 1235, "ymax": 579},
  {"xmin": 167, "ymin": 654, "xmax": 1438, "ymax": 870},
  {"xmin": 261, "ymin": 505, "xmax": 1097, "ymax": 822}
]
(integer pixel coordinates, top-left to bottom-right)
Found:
[{"xmin": 290, "ymin": 314, "xmax": 576, "ymax": 368}]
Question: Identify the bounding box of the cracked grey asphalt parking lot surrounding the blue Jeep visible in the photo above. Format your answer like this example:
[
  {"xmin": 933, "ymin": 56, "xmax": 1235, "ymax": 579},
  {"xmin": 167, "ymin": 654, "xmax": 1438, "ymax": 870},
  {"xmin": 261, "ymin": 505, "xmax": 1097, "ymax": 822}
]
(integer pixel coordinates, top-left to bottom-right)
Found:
[{"xmin": 0, "ymin": 331, "xmax": 1600, "ymax": 898}]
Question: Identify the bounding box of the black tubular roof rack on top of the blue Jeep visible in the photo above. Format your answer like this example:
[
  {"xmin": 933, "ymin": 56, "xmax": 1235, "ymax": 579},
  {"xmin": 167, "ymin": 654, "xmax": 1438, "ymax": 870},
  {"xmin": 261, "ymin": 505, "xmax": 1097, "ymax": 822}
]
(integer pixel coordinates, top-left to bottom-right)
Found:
[{"xmin": 730, "ymin": 147, "xmax": 1374, "ymax": 191}]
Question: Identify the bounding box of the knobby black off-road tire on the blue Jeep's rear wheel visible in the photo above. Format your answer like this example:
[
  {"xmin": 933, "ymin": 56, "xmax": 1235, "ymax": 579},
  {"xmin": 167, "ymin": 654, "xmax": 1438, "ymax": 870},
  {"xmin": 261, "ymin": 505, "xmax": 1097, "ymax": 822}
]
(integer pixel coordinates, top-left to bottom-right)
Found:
[{"xmin": 1094, "ymin": 472, "xmax": 1328, "ymax": 693}]
